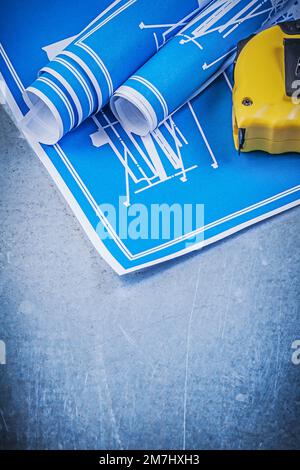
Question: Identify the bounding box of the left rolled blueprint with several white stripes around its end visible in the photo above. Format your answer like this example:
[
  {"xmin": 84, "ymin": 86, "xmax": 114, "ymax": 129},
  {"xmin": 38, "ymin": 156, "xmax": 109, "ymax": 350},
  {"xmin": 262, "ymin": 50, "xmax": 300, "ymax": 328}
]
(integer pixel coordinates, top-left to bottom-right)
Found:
[{"xmin": 21, "ymin": 0, "xmax": 211, "ymax": 144}]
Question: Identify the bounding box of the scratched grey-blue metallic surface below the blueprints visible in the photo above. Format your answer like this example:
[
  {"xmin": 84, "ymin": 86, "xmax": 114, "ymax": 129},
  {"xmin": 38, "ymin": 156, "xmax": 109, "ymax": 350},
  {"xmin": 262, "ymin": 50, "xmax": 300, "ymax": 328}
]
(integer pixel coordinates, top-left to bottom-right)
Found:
[{"xmin": 0, "ymin": 106, "xmax": 300, "ymax": 449}]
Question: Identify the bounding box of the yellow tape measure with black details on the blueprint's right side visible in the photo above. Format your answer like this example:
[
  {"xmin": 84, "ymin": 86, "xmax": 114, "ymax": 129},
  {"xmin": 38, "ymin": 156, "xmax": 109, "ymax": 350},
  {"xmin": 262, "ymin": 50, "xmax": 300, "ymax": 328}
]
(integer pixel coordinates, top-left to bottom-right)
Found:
[{"xmin": 233, "ymin": 20, "xmax": 300, "ymax": 154}]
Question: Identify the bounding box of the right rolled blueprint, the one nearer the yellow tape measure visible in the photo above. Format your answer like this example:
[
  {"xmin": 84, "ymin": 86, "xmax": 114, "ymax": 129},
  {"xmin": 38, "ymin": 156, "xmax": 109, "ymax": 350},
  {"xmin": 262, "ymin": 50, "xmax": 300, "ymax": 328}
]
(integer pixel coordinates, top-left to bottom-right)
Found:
[{"xmin": 111, "ymin": 0, "xmax": 294, "ymax": 136}]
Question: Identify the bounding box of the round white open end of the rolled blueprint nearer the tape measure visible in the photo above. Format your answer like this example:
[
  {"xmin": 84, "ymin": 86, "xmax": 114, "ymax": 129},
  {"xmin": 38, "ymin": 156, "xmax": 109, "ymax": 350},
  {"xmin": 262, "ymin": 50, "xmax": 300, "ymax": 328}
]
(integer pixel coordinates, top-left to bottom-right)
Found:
[{"xmin": 110, "ymin": 85, "xmax": 158, "ymax": 136}]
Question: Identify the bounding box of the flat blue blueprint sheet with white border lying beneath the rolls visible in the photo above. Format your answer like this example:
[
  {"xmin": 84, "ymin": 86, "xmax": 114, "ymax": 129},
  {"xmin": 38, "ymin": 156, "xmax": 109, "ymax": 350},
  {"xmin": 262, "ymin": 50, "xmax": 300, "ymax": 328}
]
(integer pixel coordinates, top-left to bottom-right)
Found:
[{"xmin": 0, "ymin": 0, "xmax": 300, "ymax": 274}]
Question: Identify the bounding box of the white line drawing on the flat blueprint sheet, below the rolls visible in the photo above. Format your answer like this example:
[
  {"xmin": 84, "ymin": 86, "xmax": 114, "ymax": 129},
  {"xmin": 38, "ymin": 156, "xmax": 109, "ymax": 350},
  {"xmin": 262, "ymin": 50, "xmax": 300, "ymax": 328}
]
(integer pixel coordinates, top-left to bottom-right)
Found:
[{"xmin": 90, "ymin": 98, "xmax": 219, "ymax": 206}]
